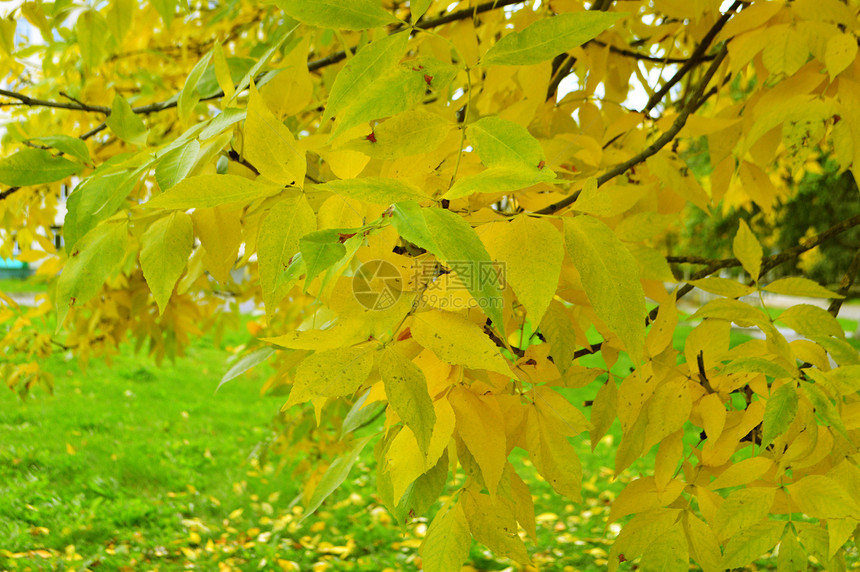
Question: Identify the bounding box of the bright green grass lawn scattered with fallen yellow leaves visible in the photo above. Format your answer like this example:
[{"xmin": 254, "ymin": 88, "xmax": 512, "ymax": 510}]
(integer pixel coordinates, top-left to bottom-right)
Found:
[{"xmin": 0, "ymin": 302, "xmax": 852, "ymax": 572}]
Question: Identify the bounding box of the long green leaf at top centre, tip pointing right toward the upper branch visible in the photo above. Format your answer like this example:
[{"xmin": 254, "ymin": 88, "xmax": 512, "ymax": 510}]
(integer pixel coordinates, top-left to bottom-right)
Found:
[{"xmin": 481, "ymin": 11, "xmax": 626, "ymax": 66}]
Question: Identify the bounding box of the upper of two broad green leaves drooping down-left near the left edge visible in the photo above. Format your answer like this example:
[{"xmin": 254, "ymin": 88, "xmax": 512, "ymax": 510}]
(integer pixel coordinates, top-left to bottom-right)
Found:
[{"xmin": 63, "ymin": 169, "xmax": 141, "ymax": 252}]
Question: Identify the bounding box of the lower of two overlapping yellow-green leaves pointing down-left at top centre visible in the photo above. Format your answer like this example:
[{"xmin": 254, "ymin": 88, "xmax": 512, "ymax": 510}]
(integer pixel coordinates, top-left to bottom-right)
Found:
[{"xmin": 329, "ymin": 67, "xmax": 427, "ymax": 140}]
